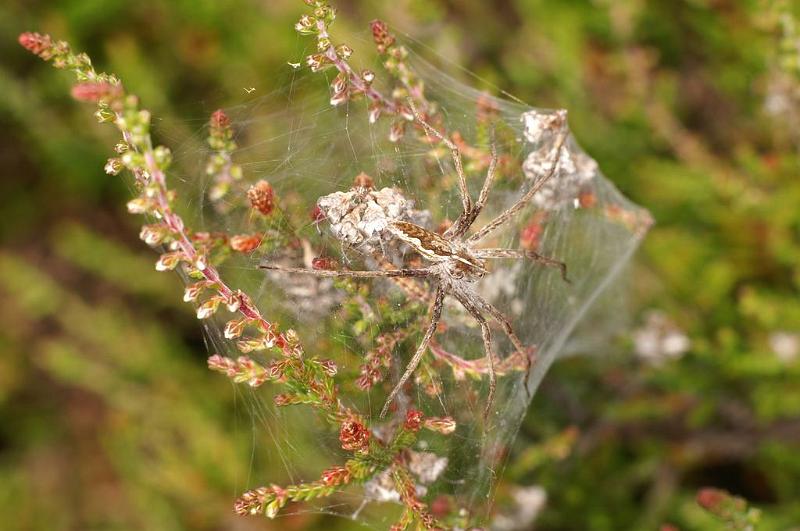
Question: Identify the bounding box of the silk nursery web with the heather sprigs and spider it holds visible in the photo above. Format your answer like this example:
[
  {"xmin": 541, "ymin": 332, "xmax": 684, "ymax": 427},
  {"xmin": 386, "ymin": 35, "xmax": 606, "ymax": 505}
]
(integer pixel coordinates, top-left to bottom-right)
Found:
[{"xmin": 21, "ymin": 1, "xmax": 651, "ymax": 529}]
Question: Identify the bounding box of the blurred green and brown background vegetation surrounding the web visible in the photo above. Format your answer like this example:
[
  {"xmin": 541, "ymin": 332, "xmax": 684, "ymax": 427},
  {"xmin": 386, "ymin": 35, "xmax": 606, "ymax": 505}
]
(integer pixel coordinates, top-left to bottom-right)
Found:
[{"xmin": 0, "ymin": 0, "xmax": 800, "ymax": 530}]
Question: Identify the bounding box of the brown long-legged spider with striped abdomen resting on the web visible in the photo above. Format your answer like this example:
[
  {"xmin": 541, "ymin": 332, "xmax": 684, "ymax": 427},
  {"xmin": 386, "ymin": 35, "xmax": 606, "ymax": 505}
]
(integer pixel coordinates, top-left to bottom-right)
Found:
[{"xmin": 259, "ymin": 102, "xmax": 567, "ymax": 418}]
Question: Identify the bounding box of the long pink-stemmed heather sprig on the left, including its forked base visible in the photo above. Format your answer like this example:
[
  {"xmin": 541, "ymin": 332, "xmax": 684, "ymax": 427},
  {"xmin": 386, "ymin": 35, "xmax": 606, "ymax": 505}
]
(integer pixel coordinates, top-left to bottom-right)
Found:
[{"xmin": 19, "ymin": 27, "xmax": 455, "ymax": 529}]
